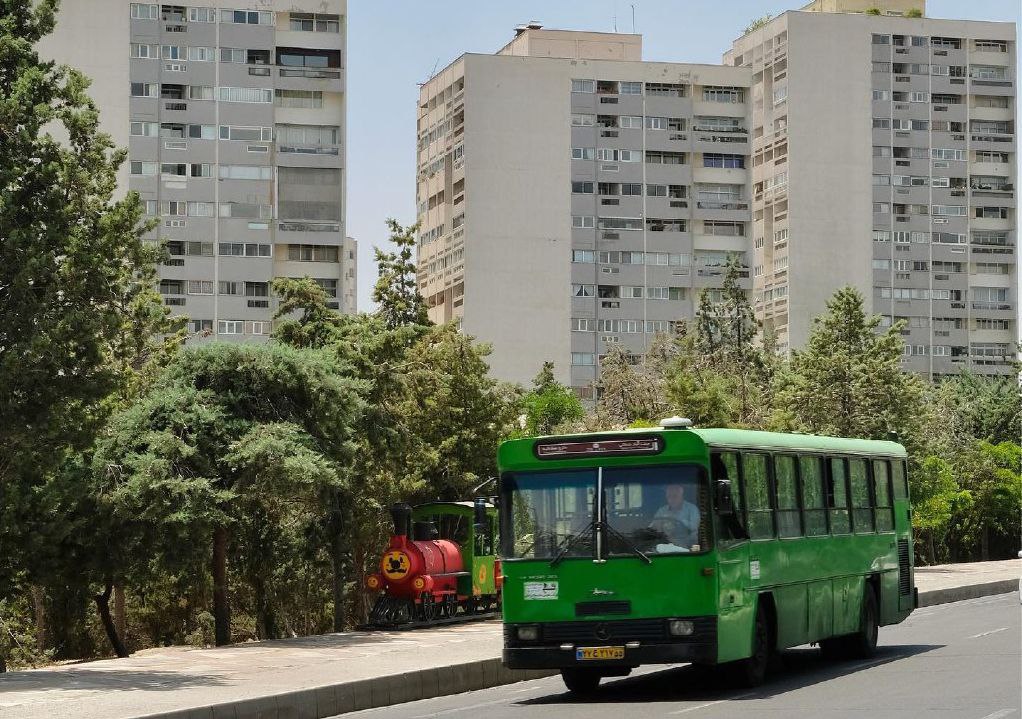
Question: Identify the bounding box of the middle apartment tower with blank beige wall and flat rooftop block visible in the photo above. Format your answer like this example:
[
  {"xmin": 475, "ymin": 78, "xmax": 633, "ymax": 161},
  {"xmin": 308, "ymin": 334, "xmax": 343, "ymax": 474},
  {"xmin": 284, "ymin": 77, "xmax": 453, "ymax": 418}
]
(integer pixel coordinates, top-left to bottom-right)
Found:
[{"xmin": 417, "ymin": 27, "xmax": 751, "ymax": 388}]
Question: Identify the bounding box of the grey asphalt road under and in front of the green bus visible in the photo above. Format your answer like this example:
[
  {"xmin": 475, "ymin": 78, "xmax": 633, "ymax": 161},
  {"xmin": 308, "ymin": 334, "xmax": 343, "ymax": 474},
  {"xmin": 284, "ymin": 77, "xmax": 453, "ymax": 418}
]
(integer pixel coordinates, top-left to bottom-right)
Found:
[{"xmin": 343, "ymin": 593, "xmax": 1022, "ymax": 719}]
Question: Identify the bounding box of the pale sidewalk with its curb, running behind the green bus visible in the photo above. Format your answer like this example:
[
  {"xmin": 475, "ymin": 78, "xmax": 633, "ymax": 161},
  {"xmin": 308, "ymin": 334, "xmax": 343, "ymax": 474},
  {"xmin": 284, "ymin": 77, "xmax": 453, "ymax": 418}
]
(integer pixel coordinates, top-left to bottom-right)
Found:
[{"xmin": 0, "ymin": 560, "xmax": 1022, "ymax": 719}]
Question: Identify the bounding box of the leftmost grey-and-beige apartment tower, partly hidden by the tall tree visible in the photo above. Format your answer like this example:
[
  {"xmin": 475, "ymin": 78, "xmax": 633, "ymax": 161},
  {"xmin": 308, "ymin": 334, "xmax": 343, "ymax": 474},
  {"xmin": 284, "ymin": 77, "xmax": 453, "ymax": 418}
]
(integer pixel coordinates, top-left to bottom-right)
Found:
[{"xmin": 41, "ymin": 0, "xmax": 357, "ymax": 341}]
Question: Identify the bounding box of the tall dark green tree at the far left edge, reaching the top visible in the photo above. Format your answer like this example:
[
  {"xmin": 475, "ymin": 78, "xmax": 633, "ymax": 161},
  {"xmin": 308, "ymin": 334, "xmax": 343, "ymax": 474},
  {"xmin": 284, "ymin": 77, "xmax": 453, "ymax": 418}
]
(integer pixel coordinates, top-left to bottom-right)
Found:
[{"xmin": 0, "ymin": 0, "xmax": 169, "ymax": 664}]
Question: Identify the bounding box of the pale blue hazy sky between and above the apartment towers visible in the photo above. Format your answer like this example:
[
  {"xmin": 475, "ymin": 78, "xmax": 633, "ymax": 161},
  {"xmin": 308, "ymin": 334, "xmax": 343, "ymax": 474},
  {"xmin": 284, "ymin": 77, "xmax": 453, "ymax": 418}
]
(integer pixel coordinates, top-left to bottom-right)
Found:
[{"xmin": 347, "ymin": 0, "xmax": 1020, "ymax": 310}]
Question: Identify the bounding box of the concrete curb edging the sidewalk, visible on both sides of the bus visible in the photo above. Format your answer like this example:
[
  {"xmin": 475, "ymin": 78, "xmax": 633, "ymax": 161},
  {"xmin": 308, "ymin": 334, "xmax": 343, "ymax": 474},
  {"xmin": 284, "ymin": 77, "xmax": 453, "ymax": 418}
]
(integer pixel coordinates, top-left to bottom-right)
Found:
[{"xmin": 141, "ymin": 579, "xmax": 1019, "ymax": 719}]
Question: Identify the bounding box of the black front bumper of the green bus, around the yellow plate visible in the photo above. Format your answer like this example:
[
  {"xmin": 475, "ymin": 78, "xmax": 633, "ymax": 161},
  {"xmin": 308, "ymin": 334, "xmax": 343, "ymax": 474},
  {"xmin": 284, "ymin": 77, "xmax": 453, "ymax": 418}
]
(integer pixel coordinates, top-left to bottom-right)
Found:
[{"xmin": 504, "ymin": 642, "xmax": 716, "ymax": 669}]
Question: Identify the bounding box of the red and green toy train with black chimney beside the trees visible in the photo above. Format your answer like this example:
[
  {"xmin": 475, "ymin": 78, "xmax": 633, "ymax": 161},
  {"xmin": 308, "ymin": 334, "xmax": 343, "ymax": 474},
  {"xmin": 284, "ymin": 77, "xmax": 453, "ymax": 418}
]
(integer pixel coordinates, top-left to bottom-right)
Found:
[{"xmin": 366, "ymin": 498, "xmax": 503, "ymax": 628}]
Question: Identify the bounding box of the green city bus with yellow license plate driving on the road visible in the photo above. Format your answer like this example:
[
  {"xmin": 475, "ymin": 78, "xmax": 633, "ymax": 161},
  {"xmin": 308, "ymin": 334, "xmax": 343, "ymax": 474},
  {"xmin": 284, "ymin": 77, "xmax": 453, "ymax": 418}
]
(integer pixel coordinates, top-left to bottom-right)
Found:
[{"xmin": 498, "ymin": 418, "xmax": 918, "ymax": 692}]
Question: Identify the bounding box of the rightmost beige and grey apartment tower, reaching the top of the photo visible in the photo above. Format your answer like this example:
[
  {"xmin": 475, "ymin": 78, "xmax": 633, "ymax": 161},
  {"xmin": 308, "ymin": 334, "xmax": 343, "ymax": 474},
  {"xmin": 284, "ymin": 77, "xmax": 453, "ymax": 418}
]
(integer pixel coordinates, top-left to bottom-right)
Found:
[{"xmin": 725, "ymin": 0, "xmax": 1018, "ymax": 377}]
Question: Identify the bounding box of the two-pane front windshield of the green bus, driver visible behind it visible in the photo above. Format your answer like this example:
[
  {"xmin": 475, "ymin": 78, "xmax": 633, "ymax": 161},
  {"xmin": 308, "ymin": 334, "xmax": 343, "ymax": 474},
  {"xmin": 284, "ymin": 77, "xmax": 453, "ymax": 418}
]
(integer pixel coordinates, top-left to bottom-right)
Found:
[{"xmin": 501, "ymin": 465, "xmax": 709, "ymax": 559}]
